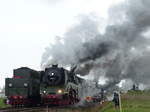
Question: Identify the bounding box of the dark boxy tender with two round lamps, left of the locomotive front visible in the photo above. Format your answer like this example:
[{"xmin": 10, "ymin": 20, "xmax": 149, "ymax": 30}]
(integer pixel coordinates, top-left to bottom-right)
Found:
[{"xmin": 5, "ymin": 67, "xmax": 40, "ymax": 106}]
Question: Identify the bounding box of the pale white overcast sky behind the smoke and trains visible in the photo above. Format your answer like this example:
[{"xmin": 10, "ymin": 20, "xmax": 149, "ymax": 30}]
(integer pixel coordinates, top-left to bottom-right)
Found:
[{"xmin": 0, "ymin": 0, "xmax": 120, "ymax": 87}]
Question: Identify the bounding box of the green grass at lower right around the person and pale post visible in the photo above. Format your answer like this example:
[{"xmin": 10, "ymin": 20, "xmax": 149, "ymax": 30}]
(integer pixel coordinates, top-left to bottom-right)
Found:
[{"xmin": 100, "ymin": 91, "xmax": 150, "ymax": 112}]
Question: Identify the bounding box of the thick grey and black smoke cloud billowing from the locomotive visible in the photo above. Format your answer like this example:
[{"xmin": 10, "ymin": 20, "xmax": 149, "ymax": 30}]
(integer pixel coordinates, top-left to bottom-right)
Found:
[{"xmin": 41, "ymin": 0, "xmax": 150, "ymax": 88}]
